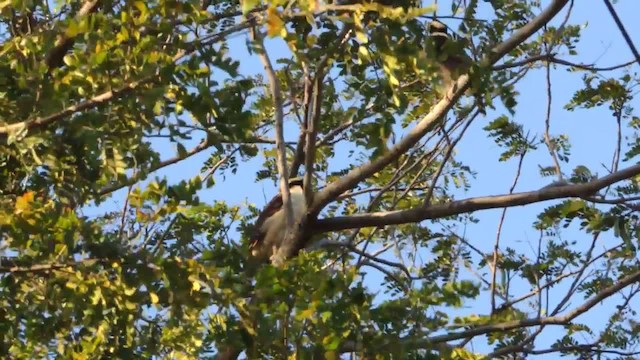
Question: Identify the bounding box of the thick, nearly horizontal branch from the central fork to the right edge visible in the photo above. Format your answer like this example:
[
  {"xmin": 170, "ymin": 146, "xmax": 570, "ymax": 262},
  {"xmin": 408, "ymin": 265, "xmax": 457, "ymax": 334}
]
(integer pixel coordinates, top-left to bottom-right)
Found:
[{"xmin": 313, "ymin": 165, "xmax": 640, "ymax": 232}]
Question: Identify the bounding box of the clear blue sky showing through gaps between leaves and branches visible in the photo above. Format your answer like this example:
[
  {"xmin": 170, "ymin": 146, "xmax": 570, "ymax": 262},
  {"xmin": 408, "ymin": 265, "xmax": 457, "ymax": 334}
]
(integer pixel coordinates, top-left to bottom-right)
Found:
[{"xmin": 91, "ymin": 0, "xmax": 640, "ymax": 351}]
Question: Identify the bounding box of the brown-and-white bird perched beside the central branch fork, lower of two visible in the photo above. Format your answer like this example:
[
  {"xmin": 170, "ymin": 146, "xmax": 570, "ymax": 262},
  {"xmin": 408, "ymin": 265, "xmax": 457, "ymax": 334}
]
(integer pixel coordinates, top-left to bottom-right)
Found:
[{"xmin": 249, "ymin": 177, "xmax": 307, "ymax": 259}]
